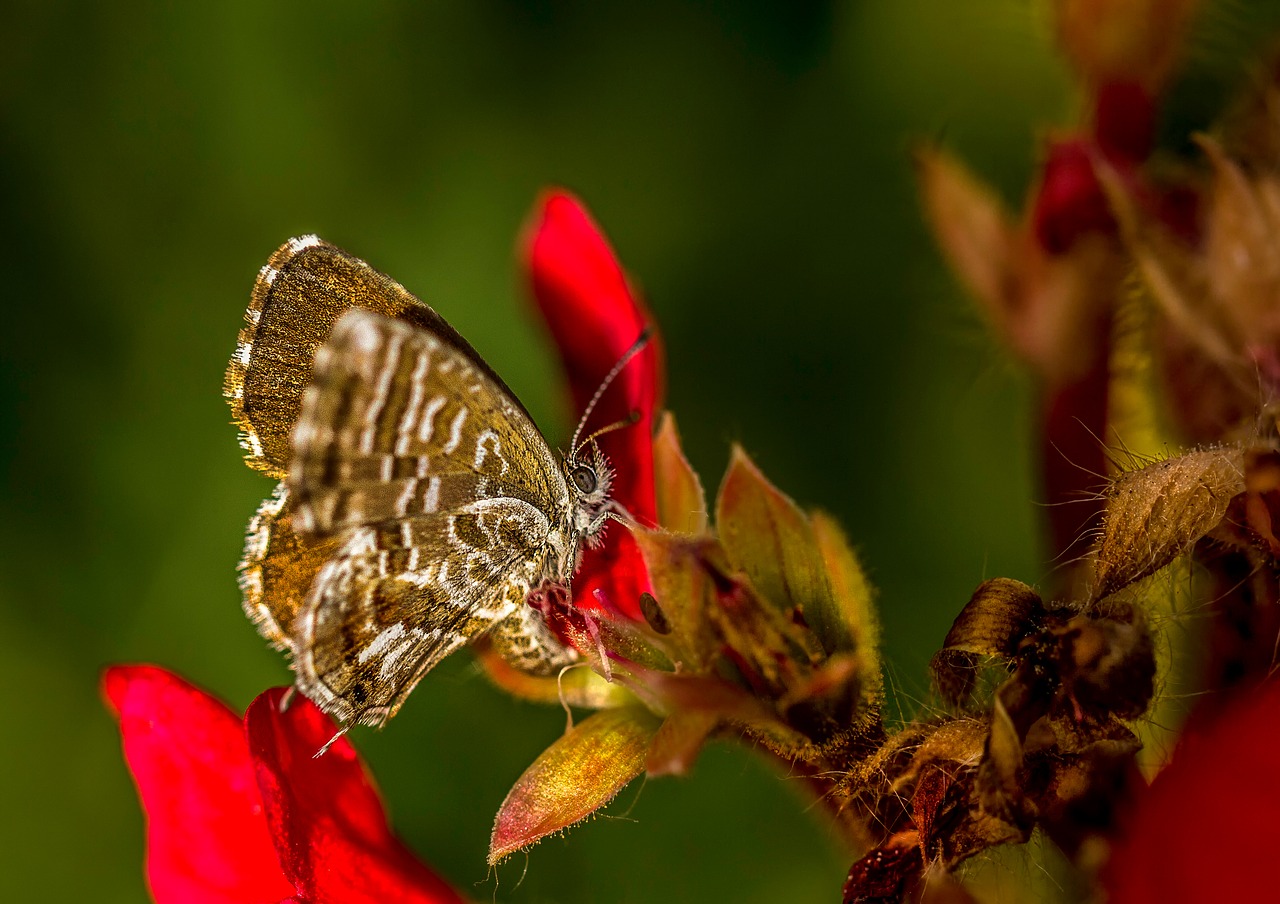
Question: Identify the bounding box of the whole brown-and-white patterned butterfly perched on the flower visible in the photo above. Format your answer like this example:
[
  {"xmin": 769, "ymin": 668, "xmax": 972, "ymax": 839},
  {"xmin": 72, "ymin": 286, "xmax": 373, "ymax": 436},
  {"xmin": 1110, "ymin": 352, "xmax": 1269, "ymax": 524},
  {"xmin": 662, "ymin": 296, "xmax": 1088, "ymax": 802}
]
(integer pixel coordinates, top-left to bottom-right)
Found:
[{"xmin": 224, "ymin": 236, "xmax": 645, "ymax": 725}]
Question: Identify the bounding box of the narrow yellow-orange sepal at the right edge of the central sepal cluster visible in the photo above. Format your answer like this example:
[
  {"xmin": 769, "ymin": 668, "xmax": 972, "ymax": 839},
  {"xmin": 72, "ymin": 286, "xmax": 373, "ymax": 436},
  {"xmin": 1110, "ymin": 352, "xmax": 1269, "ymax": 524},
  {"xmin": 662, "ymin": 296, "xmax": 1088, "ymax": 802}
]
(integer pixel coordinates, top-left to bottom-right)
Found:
[{"xmin": 805, "ymin": 512, "xmax": 883, "ymax": 699}]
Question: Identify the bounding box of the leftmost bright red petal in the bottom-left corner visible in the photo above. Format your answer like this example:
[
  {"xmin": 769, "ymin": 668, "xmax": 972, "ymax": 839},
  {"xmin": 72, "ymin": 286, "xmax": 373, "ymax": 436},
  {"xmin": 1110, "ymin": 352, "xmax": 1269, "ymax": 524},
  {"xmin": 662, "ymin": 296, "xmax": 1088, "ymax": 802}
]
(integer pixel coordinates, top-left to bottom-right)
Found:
[{"xmin": 102, "ymin": 666, "xmax": 294, "ymax": 904}]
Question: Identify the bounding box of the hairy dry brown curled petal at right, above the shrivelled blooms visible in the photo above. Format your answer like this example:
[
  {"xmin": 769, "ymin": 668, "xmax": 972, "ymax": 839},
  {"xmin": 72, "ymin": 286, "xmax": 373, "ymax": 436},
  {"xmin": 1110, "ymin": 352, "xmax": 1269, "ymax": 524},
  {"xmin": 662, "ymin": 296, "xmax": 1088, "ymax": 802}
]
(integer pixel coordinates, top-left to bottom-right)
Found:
[{"xmin": 1089, "ymin": 447, "xmax": 1244, "ymax": 601}]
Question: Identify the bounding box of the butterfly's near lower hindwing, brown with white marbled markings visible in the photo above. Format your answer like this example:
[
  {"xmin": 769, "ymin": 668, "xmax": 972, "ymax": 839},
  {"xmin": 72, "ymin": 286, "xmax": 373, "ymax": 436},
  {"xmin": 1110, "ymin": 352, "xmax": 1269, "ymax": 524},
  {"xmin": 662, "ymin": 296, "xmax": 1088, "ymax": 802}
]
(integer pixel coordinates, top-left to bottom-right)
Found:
[{"xmin": 293, "ymin": 499, "xmax": 549, "ymax": 725}]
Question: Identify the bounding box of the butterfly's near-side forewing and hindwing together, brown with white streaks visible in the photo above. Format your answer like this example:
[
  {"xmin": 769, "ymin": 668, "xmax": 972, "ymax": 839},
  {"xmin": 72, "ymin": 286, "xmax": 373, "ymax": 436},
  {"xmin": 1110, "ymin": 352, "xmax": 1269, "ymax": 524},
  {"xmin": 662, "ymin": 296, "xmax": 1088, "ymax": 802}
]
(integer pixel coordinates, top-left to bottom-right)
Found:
[{"xmin": 285, "ymin": 310, "xmax": 578, "ymax": 723}]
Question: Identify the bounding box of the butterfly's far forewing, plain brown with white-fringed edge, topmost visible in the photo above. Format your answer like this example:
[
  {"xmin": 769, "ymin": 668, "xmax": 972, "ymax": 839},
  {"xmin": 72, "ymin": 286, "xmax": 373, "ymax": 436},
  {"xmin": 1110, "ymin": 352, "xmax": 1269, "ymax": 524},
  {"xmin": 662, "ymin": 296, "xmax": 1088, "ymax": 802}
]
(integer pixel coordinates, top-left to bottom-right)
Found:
[{"xmin": 223, "ymin": 236, "xmax": 522, "ymax": 478}]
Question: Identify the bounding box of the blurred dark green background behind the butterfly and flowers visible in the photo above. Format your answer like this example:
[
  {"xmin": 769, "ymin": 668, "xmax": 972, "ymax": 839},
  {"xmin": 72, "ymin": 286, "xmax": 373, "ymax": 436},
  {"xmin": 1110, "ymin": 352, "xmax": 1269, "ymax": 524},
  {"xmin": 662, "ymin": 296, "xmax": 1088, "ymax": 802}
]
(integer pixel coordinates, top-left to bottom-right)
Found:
[{"xmin": 0, "ymin": 0, "xmax": 1280, "ymax": 903}]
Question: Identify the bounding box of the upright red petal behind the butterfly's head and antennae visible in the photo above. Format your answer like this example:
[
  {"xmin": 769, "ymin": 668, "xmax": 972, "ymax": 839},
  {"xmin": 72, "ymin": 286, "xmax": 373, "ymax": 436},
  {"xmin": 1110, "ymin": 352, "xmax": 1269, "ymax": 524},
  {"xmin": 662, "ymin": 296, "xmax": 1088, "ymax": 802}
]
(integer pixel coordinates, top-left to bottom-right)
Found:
[{"xmin": 522, "ymin": 191, "xmax": 662, "ymax": 618}]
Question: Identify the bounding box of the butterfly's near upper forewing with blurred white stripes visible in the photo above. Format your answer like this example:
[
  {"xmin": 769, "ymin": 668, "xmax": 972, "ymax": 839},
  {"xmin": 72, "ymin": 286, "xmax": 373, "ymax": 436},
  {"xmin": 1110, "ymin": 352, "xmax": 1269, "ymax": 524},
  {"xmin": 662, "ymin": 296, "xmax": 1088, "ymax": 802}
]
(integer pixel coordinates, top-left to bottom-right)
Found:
[{"xmin": 288, "ymin": 311, "xmax": 568, "ymax": 535}]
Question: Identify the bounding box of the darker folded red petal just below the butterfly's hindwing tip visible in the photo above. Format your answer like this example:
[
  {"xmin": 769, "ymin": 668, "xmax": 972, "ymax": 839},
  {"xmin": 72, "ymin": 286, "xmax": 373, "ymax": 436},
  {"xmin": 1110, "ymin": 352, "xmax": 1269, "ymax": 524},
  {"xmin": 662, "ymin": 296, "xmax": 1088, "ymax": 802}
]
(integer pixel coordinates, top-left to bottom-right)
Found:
[{"xmin": 244, "ymin": 688, "xmax": 462, "ymax": 904}]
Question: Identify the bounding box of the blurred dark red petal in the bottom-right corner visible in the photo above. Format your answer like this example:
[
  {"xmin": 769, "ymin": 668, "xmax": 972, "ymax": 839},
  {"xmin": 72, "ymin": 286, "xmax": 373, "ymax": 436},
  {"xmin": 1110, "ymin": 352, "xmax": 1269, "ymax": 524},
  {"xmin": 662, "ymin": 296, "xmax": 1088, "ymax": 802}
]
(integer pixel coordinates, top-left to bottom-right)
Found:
[{"xmin": 1103, "ymin": 681, "xmax": 1280, "ymax": 904}]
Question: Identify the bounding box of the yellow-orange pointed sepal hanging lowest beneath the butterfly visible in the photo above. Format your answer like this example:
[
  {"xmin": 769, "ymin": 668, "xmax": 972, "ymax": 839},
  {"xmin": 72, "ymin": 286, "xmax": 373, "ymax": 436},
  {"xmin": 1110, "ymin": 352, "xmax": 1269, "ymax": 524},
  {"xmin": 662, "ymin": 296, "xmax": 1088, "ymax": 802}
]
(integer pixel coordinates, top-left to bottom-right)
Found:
[{"xmin": 489, "ymin": 707, "xmax": 660, "ymax": 866}]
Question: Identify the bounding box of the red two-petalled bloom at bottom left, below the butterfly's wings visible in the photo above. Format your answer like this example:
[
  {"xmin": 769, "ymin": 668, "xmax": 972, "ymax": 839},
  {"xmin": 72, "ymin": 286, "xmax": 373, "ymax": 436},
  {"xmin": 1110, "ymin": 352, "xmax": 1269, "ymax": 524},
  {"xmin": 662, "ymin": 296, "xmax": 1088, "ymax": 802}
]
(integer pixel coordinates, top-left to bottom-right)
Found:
[{"xmin": 102, "ymin": 666, "xmax": 462, "ymax": 904}]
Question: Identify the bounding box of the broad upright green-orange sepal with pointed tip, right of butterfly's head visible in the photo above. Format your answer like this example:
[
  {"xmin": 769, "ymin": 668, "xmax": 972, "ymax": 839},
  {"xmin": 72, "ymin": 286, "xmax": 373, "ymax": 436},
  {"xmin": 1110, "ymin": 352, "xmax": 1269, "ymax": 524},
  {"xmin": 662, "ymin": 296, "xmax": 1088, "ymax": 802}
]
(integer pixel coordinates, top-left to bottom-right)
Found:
[{"xmin": 716, "ymin": 446, "xmax": 833, "ymax": 617}]
